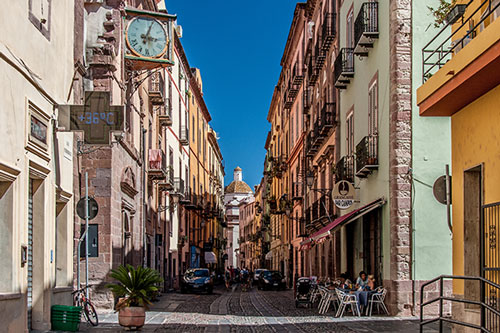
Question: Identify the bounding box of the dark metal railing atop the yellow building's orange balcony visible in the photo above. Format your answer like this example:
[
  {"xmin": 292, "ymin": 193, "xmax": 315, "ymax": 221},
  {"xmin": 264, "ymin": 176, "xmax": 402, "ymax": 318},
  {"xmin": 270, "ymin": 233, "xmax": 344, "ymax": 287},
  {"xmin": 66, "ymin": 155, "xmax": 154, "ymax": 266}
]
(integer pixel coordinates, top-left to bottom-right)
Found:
[{"xmin": 422, "ymin": 0, "xmax": 500, "ymax": 83}]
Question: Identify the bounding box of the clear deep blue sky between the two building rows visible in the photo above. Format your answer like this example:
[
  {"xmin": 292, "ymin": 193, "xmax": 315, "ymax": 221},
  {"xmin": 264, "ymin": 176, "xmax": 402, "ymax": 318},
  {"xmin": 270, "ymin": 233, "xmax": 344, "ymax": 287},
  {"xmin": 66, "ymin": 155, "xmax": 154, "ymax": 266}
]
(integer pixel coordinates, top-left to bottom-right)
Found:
[{"xmin": 166, "ymin": 0, "xmax": 297, "ymax": 188}]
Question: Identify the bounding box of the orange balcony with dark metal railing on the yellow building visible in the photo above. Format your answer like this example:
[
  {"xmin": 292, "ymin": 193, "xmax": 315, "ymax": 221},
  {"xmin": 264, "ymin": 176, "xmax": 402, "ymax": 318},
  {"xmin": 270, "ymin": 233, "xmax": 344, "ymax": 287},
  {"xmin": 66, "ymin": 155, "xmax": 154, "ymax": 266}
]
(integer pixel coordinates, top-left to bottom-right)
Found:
[{"xmin": 417, "ymin": 0, "xmax": 500, "ymax": 117}]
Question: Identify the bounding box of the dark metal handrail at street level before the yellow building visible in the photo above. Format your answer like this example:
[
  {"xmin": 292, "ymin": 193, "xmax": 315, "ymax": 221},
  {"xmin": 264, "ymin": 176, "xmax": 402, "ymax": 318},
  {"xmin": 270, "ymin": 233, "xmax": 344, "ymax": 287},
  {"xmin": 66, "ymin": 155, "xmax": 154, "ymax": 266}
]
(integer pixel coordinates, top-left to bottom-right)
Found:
[{"xmin": 420, "ymin": 275, "xmax": 500, "ymax": 333}]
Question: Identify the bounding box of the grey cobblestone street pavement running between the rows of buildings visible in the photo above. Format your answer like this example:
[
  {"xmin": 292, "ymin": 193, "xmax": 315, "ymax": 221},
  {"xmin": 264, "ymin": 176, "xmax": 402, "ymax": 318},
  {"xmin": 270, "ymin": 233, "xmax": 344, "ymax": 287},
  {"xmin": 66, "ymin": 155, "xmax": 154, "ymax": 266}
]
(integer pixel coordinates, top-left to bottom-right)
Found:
[{"xmin": 74, "ymin": 288, "xmax": 450, "ymax": 333}]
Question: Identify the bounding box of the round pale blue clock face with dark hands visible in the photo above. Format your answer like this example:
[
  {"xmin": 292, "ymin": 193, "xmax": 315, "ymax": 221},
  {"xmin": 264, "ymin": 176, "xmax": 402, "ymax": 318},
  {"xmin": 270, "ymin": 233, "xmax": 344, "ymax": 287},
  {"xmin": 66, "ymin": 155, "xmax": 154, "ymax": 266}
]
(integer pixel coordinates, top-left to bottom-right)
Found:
[{"xmin": 126, "ymin": 17, "xmax": 168, "ymax": 58}]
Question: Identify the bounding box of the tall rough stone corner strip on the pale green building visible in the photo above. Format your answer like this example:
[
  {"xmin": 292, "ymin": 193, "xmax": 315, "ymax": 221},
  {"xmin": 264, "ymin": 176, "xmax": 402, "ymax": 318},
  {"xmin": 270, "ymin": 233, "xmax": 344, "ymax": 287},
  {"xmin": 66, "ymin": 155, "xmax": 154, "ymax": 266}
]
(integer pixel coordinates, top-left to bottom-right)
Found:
[{"xmin": 388, "ymin": 0, "xmax": 412, "ymax": 316}]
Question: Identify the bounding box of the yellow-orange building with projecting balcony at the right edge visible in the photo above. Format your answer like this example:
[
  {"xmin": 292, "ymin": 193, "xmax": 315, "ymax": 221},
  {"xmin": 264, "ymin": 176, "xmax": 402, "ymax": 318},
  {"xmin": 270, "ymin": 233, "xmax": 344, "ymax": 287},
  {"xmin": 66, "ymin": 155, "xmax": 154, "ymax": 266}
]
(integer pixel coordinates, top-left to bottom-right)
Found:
[{"xmin": 417, "ymin": 0, "xmax": 500, "ymax": 326}]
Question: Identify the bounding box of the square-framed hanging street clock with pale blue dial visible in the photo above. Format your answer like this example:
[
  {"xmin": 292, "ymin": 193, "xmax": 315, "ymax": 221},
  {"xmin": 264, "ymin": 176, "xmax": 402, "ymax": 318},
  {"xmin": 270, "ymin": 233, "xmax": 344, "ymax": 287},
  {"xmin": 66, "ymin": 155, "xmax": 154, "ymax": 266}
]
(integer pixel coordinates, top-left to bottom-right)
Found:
[{"xmin": 123, "ymin": 8, "xmax": 177, "ymax": 70}]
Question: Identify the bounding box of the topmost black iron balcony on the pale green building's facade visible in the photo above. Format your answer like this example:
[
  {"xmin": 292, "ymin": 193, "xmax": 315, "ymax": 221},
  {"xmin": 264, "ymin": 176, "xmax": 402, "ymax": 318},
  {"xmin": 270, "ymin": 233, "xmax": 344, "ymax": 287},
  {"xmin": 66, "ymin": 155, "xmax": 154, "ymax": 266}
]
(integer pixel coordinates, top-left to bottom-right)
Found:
[{"xmin": 354, "ymin": 2, "xmax": 378, "ymax": 56}]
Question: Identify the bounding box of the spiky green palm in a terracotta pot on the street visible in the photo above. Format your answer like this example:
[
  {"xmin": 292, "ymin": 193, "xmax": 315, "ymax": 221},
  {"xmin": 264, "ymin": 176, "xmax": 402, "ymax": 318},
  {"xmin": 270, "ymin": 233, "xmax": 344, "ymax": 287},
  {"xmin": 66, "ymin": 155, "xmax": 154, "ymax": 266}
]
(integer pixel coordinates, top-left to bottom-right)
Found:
[{"xmin": 106, "ymin": 265, "xmax": 163, "ymax": 328}]
